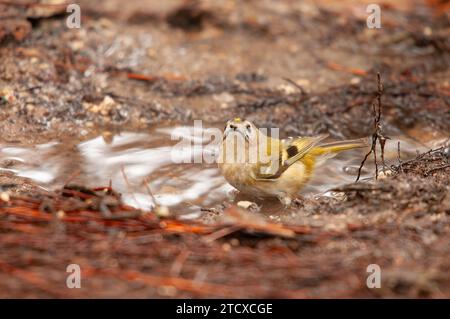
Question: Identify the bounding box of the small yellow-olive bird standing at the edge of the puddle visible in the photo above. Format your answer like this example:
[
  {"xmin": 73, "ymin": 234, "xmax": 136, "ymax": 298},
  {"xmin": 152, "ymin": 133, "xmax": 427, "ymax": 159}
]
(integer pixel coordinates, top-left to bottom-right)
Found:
[{"xmin": 217, "ymin": 118, "xmax": 368, "ymax": 206}]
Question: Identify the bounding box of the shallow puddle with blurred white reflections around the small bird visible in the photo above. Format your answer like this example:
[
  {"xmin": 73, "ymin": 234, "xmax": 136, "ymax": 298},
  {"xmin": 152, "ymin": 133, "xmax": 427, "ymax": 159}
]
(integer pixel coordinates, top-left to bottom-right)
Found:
[{"xmin": 0, "ymin": 126, "xmax": 438, "ymax": 218}]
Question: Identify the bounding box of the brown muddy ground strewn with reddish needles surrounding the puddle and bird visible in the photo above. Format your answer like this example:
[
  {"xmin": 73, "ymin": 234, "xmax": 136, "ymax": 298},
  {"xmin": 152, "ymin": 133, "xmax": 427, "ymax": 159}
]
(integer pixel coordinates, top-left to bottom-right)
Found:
[{"xmin": 0, "ymin": 0, "xmax": 450, "ymax": 298}]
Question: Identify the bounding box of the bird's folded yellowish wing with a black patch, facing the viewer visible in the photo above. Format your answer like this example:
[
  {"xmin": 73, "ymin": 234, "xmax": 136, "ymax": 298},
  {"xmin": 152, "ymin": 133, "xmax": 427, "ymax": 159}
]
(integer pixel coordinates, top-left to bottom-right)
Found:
[{"xmin": 251, "ymin": 135, "xmax": 328, "ymax": 181}]
